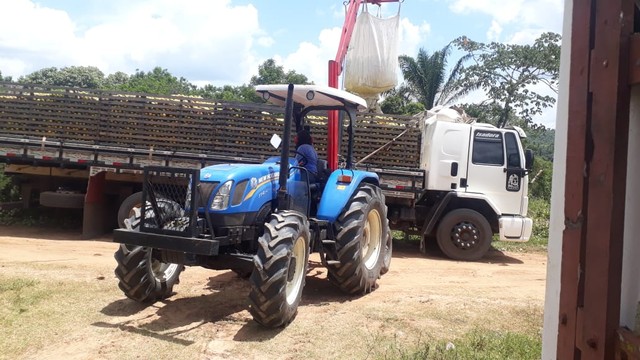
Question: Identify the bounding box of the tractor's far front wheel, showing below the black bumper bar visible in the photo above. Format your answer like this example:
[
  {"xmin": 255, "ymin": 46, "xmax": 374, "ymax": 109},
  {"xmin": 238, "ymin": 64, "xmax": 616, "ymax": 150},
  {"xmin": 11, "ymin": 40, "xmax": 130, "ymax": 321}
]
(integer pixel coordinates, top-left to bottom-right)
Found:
[{"xmin": 115, "ymin": 244, "xmax": 184, "ymax": 303}]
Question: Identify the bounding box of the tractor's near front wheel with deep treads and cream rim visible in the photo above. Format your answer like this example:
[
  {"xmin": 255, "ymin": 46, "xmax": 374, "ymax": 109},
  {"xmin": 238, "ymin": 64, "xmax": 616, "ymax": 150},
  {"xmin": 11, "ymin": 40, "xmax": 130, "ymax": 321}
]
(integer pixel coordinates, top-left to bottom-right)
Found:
[{"xmin": 249, "ymin": 211, "xmax": 309, "ymax": 328}]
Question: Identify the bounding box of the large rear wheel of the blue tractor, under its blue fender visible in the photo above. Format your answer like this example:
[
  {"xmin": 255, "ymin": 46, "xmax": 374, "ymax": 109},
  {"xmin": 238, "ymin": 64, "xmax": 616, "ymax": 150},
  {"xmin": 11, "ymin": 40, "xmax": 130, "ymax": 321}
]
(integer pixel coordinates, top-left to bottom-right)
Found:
[{"xmin": 327, "ymin": 184, "xmax": 389, "ymax": 294}]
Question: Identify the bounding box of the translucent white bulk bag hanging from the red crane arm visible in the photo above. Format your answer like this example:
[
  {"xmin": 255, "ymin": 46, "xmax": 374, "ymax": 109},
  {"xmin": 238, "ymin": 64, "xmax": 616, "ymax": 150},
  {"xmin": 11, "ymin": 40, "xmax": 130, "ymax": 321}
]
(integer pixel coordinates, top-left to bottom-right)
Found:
[{"xmin": 344, "ymin": 8, "xmax": 400, "ymax": 97}]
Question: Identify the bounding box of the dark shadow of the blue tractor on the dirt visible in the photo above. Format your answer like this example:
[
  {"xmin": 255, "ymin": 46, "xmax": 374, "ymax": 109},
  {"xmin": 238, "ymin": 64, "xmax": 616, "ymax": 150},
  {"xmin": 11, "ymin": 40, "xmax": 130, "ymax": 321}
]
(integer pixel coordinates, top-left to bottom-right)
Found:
[{"xmin": 98, "ymin": 261, "xmax": 357, "ymax": 346}]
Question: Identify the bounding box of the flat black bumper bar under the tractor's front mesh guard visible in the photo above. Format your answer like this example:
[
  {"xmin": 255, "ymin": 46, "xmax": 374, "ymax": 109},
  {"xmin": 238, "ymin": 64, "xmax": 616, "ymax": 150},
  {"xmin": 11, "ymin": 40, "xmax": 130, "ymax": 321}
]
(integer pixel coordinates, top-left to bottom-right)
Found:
[{"xmin": 113, "ymin": 229, "xmax": 220, "ymax": 255}]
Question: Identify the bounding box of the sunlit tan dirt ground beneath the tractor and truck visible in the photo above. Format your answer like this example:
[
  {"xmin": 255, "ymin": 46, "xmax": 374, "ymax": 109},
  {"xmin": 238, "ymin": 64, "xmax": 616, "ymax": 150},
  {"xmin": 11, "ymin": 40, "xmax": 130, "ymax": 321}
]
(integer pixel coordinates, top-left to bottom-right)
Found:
[{"xmin": 0, "ymin": 227, "xmax": 546, "ymax": 359}]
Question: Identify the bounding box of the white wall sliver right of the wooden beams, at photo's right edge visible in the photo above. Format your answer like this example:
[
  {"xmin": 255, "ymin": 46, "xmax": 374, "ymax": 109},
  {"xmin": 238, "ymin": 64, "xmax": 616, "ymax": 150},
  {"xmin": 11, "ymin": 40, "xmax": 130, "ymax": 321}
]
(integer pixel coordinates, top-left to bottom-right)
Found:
[{"xmin": 620, "ymin": 86, "xmax": 640, "ymax": 330}]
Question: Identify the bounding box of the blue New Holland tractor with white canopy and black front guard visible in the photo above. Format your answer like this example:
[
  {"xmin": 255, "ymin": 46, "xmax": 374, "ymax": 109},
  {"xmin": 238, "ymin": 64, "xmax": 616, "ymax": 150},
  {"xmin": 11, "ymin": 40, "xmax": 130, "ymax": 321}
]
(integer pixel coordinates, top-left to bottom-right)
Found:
[{"xmin": 114, "ymin": 84, "xmax": 391, "ymax": 327}]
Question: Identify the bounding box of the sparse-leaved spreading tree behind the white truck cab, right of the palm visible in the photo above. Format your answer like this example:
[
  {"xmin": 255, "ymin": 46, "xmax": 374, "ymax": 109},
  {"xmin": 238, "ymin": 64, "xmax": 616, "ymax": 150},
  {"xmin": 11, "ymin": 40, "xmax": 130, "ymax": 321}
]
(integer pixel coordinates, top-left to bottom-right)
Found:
[{"xmin": 454, "ymin": 32, "xmax": 560, "ymax": 127}]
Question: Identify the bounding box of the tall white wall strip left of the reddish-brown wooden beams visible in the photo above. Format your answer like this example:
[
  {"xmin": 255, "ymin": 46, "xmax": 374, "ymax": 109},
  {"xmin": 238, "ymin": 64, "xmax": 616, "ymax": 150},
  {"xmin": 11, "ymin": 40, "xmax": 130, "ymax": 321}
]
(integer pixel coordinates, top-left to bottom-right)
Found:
[{"xmin": 542, "ymin": 0, "xmax": 577, "ymax": 360}]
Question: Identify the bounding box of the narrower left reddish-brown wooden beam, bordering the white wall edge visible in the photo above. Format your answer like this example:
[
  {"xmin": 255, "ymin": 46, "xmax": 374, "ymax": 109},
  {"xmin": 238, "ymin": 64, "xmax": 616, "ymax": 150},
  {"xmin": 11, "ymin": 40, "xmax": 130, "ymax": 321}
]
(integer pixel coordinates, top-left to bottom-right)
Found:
[{"xmin": 556, "ymin": 0, "xmax": 592, "ymax": 359}]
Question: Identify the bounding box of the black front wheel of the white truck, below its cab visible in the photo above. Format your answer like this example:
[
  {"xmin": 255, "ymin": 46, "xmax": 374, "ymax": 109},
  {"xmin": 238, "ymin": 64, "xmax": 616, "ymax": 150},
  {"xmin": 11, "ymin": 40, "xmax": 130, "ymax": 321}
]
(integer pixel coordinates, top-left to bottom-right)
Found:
[{"xmin": 437, "ymin": 209, "xmax": 493, "ymax": 261}]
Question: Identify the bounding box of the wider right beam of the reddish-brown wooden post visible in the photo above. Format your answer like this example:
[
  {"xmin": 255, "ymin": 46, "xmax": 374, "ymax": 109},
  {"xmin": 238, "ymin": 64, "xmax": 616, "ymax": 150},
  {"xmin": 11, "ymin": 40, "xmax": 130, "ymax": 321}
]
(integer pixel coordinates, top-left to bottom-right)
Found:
[{"xmin": 578, "ymin": 0, "xmax": 635, "ymax": 359}]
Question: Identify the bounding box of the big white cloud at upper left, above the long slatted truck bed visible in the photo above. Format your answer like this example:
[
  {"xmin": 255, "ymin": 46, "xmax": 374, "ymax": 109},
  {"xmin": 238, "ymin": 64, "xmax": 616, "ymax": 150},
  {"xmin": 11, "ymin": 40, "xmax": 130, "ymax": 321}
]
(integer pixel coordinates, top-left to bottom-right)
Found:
[{"xmin": 0, "ymin": 0, "xmax": 273, "ymax": 84}]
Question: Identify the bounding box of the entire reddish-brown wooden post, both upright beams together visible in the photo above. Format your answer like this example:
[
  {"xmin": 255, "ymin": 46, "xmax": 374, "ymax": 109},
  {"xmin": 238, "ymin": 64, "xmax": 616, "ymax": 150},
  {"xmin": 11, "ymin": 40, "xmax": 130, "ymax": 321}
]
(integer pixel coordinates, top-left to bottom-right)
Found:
[{"xmin": 557, "ymin": 0, "xmax": 635, "ymax": 359}]
